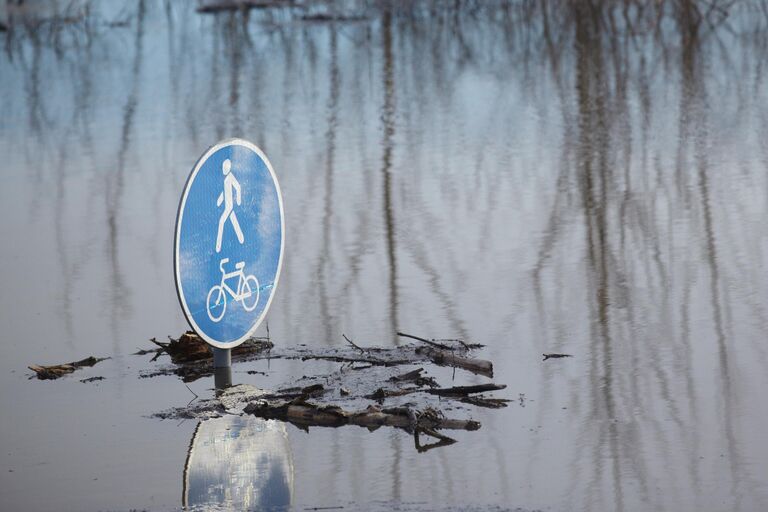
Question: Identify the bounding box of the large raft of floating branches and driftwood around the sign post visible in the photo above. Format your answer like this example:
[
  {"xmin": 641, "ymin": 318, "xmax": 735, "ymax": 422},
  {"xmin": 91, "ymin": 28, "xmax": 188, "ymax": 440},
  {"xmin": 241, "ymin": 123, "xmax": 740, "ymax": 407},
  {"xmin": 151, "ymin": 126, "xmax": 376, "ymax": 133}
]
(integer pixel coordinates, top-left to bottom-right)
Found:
[{"xmin": 149, "ymin": 333, "xmax": 509, "ymax": 451}]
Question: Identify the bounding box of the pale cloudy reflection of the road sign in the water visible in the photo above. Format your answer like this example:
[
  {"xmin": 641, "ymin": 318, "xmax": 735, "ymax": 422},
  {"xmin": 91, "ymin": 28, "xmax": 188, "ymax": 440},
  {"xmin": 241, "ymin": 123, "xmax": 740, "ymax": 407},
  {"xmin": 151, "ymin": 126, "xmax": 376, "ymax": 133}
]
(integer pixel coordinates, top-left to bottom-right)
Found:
[{"xmin": 182, "ymin": 416, "xmax": 293, "ymax": 510}]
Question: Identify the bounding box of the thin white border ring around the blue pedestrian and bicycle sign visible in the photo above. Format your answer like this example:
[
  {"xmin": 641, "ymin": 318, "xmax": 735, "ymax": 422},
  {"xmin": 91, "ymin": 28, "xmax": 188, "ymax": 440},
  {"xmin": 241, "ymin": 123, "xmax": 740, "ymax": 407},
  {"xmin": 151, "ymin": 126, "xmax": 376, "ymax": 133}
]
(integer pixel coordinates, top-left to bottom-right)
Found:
[{"xmin": 173, "ymin": 138, "xmax": 285, "ymax": 349}]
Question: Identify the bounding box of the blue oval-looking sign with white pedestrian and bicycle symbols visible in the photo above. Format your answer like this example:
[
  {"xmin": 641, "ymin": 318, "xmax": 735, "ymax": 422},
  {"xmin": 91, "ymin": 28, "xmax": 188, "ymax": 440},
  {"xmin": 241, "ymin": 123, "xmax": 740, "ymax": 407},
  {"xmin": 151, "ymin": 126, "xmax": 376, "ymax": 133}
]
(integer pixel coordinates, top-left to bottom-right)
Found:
[{"xmin": 174, "ymin": 139, "xmax": 285, "ymax": 348}]
